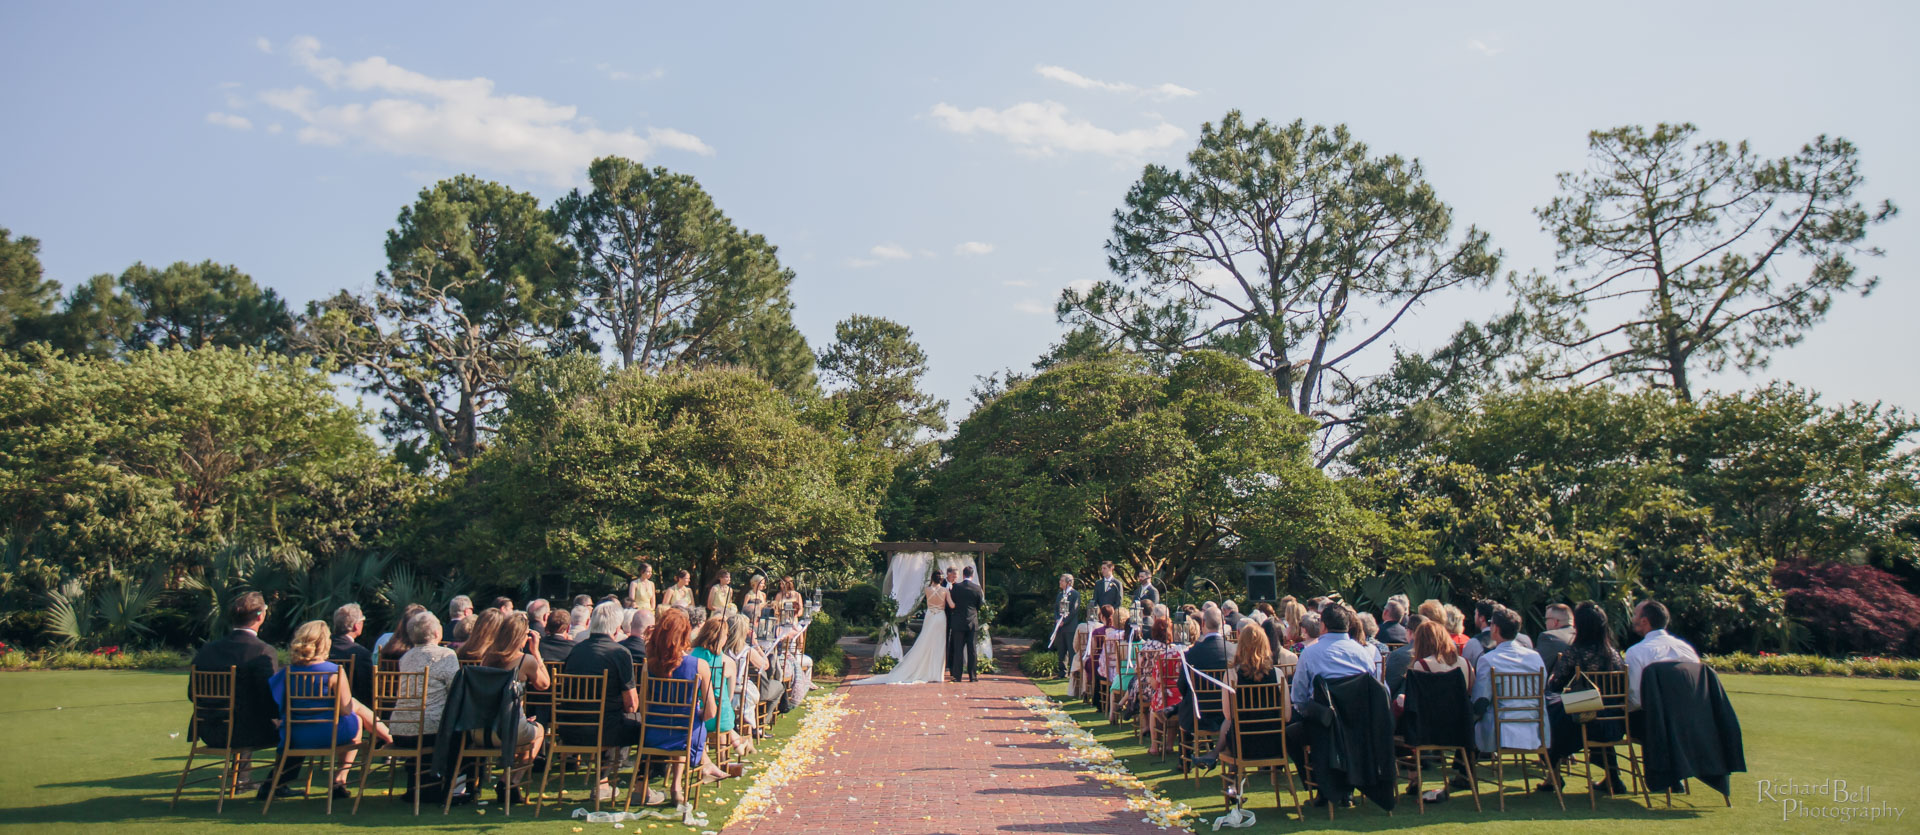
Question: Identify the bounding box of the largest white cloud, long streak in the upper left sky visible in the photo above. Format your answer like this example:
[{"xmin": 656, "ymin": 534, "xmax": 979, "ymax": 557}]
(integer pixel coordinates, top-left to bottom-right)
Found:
[{"xmin": 247, "ymin": 36, "xmax": 714, "ymax": 184}]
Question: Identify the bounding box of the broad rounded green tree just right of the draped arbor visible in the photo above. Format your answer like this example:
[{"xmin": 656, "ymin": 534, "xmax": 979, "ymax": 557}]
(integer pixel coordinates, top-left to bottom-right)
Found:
[{"xmin": 935, "ymin": 349, "xmax": 1373, "ymax": 585}]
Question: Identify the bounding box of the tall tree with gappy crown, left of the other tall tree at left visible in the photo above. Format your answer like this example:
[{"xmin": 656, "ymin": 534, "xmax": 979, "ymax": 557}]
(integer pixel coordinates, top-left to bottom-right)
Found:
[{"xmin": 300, "ymin": 175, "xmax": 580, "ymax": 465}]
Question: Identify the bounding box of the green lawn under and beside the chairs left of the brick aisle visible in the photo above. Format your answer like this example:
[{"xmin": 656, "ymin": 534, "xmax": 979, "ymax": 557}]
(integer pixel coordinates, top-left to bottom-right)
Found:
[{"xmin": 0, "ymin": 670, "xmax": 820, "ymax": 835}]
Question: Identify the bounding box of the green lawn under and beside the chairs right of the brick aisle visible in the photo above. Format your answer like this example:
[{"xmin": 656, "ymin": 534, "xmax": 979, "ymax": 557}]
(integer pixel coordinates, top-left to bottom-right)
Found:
[{"xmin": 1041, "ymin": 676, "xmax": 1920, "ymax": 833}]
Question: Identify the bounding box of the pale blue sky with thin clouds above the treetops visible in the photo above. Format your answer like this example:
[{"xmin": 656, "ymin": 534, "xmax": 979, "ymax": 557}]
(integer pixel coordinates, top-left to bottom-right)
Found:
[{"xmin": 0, "ymin": 2, "xmax": 1920, "ymax": 418}]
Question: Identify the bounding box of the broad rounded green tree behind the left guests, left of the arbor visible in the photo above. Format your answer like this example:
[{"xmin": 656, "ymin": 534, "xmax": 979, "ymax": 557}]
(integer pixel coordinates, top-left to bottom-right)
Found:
[{"xmin": 417, "ymin": 355, "xmax": 885, "ymax": 582}]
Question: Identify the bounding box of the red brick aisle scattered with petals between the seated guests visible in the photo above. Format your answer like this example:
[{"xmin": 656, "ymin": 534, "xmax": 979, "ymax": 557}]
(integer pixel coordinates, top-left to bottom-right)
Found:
[{"xmin": 728, "ymin": 647, "xmax": 1160, "ymax": 835}]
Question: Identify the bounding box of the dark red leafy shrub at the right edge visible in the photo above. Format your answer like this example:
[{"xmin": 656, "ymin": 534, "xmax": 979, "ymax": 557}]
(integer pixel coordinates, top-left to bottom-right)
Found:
[{"xmin": 1774, "ymin": 561, "xmax": 1920, "ymax": 655}]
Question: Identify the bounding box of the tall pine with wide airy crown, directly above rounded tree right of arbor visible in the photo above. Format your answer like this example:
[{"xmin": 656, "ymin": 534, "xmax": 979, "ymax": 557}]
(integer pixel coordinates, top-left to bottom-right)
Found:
[{"xmin": 1058, "ymin": 111, "xmax": 1500, "ymax": 465}]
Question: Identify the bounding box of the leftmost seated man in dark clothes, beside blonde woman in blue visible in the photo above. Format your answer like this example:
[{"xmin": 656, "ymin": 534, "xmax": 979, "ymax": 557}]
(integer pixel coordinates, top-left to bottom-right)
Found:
[{"xmin": 194, "ymin": 591, "xmax": 300, "ymax": 800}]
